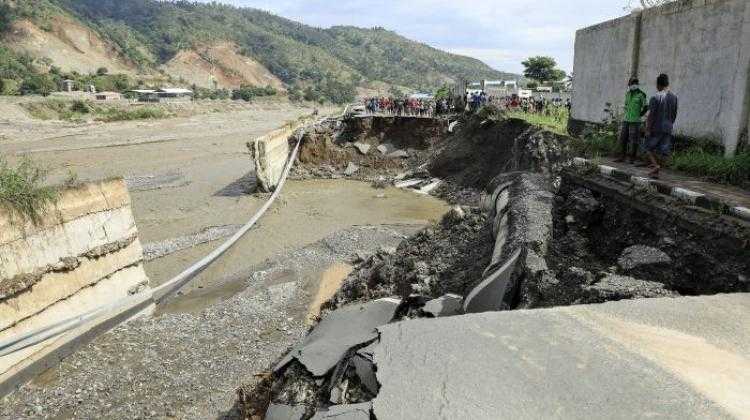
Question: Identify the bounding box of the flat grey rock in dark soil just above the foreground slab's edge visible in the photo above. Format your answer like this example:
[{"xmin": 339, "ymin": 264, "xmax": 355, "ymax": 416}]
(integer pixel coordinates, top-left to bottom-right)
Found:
[{"xmin": 583, "ymin": 274, "xmax": 679, "ymax": 303}]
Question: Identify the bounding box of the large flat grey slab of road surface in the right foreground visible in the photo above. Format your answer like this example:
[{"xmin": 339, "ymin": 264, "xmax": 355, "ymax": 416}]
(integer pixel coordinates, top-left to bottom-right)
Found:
[{"xmin": 373, "ymin": 294, "xmax": 750, "ymax": 420}]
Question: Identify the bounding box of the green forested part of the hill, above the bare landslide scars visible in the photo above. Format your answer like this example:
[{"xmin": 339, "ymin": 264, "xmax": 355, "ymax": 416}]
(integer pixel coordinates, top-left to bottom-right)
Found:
[{"xmin": 0, "ymin": 0, "xmax": 516, "ymax": 100}]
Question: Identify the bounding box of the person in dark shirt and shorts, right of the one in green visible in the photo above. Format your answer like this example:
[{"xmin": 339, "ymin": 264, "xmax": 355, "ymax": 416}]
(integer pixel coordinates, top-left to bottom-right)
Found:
[{"xmin": 645, "ymin": 74, "xmax": 678, "ymax": 178}]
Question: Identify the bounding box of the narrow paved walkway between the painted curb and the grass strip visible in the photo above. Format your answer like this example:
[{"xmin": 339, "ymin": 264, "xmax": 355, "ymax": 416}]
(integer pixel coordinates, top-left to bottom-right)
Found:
[{"xmin": 601, "ymin": 158, "xmax": 750, "ymax": 208}]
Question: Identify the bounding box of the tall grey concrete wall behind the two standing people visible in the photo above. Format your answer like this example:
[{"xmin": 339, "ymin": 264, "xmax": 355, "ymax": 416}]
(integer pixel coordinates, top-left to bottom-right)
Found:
[{"xmin": 571, "ymin": 0, "xmax": 750, "ymax": 154}]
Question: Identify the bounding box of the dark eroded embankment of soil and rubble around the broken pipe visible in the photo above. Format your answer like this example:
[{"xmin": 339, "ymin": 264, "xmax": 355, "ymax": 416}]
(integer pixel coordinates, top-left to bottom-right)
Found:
[{"xmin": 240, "ymin": 112, "xmax": 750, "ymax": 420}]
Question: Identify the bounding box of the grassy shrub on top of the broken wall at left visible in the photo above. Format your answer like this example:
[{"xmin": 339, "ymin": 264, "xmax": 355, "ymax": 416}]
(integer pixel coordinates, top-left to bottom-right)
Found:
[{"xmin": 0, "ymin": 157, "xmax": 57, "ymax": 223}]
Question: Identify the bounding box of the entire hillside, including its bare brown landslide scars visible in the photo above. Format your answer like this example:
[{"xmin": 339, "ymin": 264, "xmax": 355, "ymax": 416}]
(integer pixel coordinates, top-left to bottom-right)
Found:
[{"xmin": 0, "ymin": 0, "xmax": 517, "ymax": 102}]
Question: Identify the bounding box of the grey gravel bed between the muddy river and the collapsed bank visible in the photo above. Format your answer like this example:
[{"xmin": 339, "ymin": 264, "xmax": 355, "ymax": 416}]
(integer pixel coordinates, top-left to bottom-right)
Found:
[{"xmin": 0, "ymin": 225, "xmax": 419, "ymax": 420}]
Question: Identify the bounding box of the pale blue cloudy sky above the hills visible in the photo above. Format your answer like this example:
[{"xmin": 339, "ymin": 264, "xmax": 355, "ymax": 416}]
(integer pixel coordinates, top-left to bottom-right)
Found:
[{"xmin": 198, "ymin": 0, "xmax": 628, "ymax": 73}]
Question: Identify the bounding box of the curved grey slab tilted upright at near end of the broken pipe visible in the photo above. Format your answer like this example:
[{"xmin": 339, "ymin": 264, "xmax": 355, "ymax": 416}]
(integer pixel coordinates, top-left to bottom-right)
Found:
[{"xmin": 464, "ymin": 249, "xmax": 521, "ymax": 313}]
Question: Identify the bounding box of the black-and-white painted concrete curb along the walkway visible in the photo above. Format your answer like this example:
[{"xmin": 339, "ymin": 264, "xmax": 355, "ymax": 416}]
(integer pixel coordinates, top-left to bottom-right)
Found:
[{"xmin": 573, "ymin": 157, "xmax": 750, "ymax": 222}]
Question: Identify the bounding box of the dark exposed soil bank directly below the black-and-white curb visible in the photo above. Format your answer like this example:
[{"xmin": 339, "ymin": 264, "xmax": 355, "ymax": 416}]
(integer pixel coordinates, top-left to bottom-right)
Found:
[{"xmin": 546, "ymin": 172, "xmax": 750, "ymax": 304}]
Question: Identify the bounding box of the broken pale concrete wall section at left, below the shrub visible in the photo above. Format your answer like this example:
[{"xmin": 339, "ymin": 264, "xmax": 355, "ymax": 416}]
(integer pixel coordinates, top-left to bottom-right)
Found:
[{"xmin": 0, "ymin": 180, "xmax": 150, "ymax": 382}]
